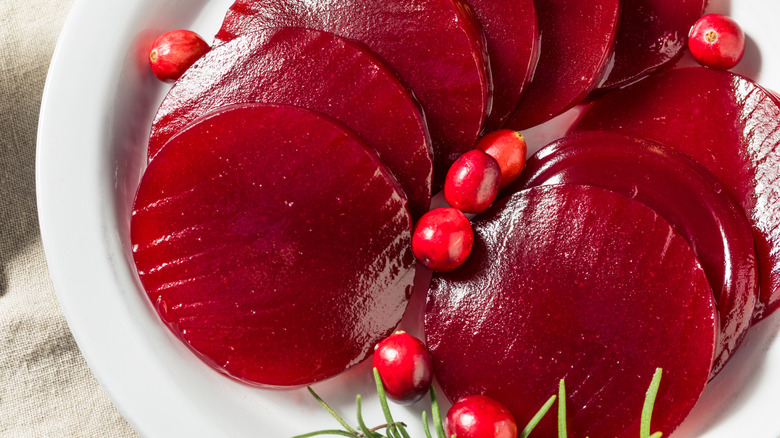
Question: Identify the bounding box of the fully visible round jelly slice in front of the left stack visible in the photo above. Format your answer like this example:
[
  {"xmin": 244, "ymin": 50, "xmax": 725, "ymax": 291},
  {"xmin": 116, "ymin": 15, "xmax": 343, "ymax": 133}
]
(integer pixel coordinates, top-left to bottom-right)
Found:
[{"xmin": 131, "ymin": 105, "xmax": 414, "ymax": 387}]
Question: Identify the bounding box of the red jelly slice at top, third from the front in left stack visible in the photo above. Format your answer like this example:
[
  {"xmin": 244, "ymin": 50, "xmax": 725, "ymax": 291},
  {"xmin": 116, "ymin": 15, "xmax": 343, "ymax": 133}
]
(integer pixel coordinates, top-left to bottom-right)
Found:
[{"xmin": 216, "ymin": 0, "xmax": 491, "ymax": 185}]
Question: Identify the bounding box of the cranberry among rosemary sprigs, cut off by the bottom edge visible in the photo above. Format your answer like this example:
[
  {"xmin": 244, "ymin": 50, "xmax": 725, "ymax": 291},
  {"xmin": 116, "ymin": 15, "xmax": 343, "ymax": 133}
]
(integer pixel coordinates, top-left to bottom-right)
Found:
[{"xmin": 445, "ymin": 395, "xmax": 517, "ymax": 438}]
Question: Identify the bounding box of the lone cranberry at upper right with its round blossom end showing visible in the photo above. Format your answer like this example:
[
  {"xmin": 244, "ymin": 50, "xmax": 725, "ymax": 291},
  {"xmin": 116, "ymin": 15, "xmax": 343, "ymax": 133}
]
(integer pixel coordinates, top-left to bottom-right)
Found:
[{"xmin": 688, "ymin": 14, "xmax": 745, "ymax": 70}]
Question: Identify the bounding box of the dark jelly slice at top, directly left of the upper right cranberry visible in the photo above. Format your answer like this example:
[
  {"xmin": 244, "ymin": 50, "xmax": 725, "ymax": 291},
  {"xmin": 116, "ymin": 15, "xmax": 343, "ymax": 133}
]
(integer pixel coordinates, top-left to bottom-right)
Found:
[{"xmin": 598, "ymin": 0, "xmax": 704, "ymax": 91}]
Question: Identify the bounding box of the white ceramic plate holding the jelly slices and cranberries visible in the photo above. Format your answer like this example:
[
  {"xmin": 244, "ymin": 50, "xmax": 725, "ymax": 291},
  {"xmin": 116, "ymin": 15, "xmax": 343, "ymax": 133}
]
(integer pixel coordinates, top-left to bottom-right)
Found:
[{"xmin": 36, "ymin": 0, "xmax": 780, "ymax": 438}]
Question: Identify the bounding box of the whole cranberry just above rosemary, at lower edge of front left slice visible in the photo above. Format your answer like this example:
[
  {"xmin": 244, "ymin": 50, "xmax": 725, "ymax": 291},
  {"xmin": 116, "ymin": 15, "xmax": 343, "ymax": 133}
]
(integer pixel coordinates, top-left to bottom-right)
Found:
[{"xmin": 374, "ymin": 331, "xmax": 433, "ymax": 405}]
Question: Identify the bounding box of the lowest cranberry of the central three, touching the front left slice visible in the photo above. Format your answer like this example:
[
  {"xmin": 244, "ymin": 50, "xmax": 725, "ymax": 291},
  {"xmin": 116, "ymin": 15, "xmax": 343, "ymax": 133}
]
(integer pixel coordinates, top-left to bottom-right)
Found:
[{"xmin": 412, "ymin": 208, "xmax": 474, "ymax": 272}]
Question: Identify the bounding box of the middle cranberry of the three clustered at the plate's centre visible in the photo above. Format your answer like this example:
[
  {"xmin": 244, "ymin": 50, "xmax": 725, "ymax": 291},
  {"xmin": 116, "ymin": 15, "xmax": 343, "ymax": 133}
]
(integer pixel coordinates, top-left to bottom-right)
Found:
[{"xmin": 444, "ymin": 149, "xmax": 501, "ymax": 213}]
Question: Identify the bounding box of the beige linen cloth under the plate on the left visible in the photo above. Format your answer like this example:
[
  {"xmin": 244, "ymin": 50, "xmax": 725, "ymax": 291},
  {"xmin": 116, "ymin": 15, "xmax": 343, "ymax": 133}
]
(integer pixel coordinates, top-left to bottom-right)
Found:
[{"xmin": 0, "ymin": 0, "xmax": 136, "ymax": 438}]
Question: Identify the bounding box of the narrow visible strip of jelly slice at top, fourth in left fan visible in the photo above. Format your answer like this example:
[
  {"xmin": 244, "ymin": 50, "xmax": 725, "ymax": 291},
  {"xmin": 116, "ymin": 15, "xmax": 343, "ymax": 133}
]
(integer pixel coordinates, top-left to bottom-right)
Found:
[{"xmin": 468, "ymin": 0, "xmax": 539, "ymax": 132}]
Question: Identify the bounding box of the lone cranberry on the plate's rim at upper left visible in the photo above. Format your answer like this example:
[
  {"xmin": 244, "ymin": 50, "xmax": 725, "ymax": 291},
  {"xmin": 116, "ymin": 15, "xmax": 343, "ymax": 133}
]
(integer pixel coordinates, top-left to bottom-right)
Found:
[{"xmin": 149, "ymin": 30, "xmax": 211, "ymax": 82}]
